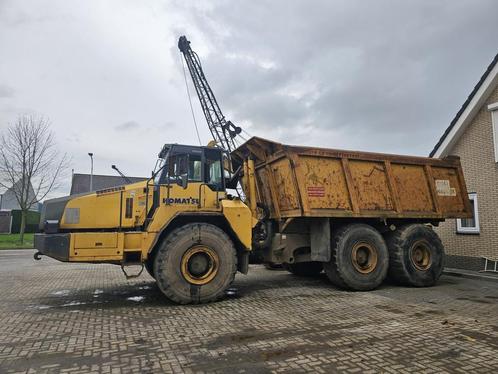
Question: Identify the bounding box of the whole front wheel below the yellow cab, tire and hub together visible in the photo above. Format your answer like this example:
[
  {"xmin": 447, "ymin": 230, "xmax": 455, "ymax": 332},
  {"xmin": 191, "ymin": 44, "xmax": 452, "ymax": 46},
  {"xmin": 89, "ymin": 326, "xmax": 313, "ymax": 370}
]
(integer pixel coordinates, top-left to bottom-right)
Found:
[{"xmin": 154, "ymin": 223, "xmax": 237, "ymax": 304}]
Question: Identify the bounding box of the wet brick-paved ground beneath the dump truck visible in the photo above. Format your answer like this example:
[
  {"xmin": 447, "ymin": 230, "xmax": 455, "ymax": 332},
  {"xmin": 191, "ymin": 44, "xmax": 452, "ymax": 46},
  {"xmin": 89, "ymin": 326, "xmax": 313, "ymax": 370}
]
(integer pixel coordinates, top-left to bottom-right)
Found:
[{"xmin": 0, "ymin": 251, "xmax": 498, "ymax": 373}]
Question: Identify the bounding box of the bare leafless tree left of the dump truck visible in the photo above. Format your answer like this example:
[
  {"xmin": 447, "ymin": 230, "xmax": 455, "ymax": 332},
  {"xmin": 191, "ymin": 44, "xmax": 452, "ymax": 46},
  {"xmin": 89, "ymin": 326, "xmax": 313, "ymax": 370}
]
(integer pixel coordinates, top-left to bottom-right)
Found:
[{"xmin": 0, "ymin": 115, "xmax": 68, "ymax": 243}]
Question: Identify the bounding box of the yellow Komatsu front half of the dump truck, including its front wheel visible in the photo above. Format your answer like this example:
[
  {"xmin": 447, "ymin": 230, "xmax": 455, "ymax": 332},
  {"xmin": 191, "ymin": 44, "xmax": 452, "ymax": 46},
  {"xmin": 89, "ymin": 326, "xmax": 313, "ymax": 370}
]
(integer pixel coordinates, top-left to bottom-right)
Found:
[{"xmin": 35, "ymin": 144, "xmax": 255, "ymax": 303}]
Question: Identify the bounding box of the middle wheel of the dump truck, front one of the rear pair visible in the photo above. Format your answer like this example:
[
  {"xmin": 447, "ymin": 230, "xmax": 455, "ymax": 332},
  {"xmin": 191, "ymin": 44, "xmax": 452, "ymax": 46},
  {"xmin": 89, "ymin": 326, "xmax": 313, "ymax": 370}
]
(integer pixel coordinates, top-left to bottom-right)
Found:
[{"xmin": 323, "ymin": 224, "xmax": 389, "ymax": 291}]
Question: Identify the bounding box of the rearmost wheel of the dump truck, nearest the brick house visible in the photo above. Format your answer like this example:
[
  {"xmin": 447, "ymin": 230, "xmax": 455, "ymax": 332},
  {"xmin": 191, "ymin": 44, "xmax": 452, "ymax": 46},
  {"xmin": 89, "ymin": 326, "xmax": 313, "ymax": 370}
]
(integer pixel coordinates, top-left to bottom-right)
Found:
[{"xmin": 385, "ymin": 224, "xmax": 444, "ymax": 287}]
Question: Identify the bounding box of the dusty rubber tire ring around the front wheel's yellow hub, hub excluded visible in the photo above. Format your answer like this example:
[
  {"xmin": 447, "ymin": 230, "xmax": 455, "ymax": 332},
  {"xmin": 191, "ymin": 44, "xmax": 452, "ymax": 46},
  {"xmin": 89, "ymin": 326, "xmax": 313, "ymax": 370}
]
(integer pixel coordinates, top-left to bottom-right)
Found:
[{"xmin": 154, "ymin": 223, "xmax": 237, "ymax": 304}]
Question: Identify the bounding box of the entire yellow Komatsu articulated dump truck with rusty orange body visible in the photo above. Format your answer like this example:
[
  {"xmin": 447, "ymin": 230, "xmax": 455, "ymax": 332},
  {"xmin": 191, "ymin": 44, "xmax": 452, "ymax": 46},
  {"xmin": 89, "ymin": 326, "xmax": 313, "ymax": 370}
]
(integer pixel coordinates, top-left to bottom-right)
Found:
[{"xmin": 35, "ymin": 137, "xmax": 471, "ymax": 304}]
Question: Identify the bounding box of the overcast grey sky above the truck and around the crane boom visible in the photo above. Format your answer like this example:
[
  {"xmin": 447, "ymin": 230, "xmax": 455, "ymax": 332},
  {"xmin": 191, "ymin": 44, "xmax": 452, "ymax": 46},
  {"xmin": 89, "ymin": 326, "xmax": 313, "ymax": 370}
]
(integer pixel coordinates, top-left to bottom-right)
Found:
[{"xmin": 0, "ymin": 0, "xmax": 498, "ymax": 194}]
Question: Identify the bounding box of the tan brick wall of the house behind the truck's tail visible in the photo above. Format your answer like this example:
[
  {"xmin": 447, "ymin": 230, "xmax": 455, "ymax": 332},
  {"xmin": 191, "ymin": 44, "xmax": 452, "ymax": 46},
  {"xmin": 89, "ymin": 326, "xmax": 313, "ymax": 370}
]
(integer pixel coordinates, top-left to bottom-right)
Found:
[{"xmin": 436, "ymin": 83, "xmax": 498, "ymax": 270}]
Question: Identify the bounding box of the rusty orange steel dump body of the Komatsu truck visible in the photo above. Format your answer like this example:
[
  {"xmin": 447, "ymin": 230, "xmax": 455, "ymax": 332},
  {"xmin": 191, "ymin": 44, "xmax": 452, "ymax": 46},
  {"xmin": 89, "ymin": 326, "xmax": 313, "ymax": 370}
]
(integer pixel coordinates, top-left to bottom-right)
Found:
[{"xmin": 233, "ymin": 137, "xmax": 471, "ymax": 221}]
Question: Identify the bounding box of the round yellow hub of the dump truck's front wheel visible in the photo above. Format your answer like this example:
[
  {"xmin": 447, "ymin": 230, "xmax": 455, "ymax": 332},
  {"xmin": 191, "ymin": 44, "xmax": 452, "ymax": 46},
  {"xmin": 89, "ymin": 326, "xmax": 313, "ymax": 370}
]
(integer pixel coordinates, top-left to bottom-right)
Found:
[{"xmin": 181, "ymin": 246, "xmax": 219, "ymax": 285}]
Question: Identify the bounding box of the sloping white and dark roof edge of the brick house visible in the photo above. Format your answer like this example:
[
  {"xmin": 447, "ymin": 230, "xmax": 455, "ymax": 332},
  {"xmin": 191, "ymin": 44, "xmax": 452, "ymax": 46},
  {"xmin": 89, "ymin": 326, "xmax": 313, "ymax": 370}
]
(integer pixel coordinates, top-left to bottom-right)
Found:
[{"xmin": 429, "ymin": 54, "xmax": 498, "ymax": 157}]
